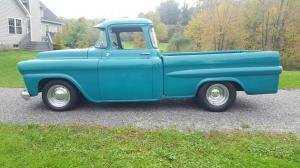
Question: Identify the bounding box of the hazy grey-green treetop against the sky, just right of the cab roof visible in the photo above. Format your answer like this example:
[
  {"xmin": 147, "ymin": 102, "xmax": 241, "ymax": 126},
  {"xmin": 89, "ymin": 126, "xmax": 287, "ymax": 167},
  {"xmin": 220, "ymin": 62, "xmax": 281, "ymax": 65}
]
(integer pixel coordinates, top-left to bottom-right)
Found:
[{"xmin": 157, "ymin": 0, "xmax": 180, "ymax": 25}]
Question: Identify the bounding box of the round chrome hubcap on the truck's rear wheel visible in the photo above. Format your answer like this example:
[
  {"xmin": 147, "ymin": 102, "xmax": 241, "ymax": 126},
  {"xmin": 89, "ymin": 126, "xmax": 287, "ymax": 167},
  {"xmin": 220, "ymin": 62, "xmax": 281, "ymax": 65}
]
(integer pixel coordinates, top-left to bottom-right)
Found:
[{"xmin": 206, "ymin": 84, "xmax": 229, "ymax": 106}]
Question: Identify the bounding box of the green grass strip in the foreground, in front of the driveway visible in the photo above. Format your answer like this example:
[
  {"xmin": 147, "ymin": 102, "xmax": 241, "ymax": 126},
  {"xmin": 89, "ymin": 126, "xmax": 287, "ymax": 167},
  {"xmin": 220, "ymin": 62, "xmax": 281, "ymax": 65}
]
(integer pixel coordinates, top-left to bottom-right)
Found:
[{"xmin": 0, "ymin": 124, "xmax": 300, "ymax": 168}]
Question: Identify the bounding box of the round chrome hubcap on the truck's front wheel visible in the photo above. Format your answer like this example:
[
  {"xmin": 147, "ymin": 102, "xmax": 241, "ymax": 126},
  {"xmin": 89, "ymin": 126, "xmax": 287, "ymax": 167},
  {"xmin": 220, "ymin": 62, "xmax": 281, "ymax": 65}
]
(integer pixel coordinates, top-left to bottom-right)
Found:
[{"xmin": 47, "ymin": 85, "xmax": 71, "ymax": 108}]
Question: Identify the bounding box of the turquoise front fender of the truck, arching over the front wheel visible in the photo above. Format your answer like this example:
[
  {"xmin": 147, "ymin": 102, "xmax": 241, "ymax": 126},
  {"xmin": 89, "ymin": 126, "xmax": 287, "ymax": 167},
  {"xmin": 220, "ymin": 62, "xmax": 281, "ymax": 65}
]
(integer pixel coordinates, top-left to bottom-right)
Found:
[{"xmin": 18, "ymin": 58, "xmax": 100, "ymax": 102}]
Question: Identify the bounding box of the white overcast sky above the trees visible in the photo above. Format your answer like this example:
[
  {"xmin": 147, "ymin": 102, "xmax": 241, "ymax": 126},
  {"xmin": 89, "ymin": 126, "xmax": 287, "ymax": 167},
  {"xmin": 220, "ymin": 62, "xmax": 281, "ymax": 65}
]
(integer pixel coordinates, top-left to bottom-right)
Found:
[{"xmin": 42, "ymin": 0, "xmax": 197, "ymax": 19}]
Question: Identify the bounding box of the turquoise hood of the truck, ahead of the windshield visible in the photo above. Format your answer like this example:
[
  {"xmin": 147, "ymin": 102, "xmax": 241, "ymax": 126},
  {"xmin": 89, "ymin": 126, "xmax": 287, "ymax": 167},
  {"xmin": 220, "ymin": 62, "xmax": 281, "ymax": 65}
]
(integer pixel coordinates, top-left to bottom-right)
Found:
[{"xmin": 37, "ymin": 49, "xmax": 89, "ymax": 59}]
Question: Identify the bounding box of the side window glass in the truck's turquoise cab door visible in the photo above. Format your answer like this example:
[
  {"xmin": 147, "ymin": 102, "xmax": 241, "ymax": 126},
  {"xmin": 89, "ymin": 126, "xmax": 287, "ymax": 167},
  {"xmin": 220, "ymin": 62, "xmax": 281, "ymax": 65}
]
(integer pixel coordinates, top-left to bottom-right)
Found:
[{"xmin": 111, "ymin": 27, "xmax": 146, "ymax": 49}]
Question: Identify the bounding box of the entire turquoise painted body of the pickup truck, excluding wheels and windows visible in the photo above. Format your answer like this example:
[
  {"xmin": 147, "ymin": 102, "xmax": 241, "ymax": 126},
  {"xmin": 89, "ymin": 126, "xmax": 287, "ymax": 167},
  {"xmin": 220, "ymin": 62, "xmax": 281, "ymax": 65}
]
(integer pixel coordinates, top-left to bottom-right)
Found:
[{"xmin": 18, "ymin": 19, "xmax": 282, "ymax": 102}]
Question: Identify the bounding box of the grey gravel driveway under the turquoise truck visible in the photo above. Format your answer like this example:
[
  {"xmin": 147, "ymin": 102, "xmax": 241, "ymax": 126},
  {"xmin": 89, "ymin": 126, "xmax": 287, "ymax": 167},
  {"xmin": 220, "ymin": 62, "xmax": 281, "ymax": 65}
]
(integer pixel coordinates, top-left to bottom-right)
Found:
[{"xmin": 0, "ymin": 88, "xmax": 300, "ymax": 133}]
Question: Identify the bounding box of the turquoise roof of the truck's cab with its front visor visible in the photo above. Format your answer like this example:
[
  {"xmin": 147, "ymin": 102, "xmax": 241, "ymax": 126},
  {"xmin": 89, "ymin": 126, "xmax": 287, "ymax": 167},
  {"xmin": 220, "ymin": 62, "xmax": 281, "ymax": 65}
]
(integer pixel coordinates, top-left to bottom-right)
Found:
[{"xmin": 95, "ymin": 18, "xmax": 153, "ymax": 29}]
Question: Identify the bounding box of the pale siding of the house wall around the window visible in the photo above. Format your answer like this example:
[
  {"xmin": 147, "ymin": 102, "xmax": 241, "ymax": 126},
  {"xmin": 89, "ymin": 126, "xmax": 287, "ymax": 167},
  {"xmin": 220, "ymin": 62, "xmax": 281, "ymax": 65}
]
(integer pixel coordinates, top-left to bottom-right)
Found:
[{"xmin": 0, "ymin": 0, "xmax": 28, "ymax": 49}]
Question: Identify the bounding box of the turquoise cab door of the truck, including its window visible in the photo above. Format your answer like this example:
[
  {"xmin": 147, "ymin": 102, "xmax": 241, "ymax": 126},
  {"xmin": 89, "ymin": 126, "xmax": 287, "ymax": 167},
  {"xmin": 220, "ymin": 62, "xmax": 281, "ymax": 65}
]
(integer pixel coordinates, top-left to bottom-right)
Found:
[{"xmin": 99, "ymin": 27, "xmax": 154, "ymax": 101}]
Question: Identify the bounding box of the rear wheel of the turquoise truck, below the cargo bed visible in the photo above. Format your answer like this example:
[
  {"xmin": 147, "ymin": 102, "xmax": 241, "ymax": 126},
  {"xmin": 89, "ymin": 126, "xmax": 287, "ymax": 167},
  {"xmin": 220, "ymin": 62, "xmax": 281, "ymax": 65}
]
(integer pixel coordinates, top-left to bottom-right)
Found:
[{"xmin": 197, "ymin": 82, "xmax": 236, "ymax": 112}]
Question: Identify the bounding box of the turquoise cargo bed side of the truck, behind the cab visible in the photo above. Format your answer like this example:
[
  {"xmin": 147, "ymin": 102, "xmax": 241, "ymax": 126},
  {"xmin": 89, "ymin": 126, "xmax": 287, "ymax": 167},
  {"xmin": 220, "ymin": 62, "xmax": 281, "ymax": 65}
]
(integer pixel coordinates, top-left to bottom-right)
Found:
[{"xmin": 162, "ymin": 50, "xmax": 282, "ymax": 97}]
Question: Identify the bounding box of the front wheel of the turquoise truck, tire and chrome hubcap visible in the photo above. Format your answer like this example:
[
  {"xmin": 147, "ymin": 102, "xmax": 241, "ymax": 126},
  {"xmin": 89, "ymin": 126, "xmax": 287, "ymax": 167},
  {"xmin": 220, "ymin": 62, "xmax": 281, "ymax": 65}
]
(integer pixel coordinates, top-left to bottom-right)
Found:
[{"xmin": 42, "ymin": 80, "xmax": 79, "ymax": 111}]
